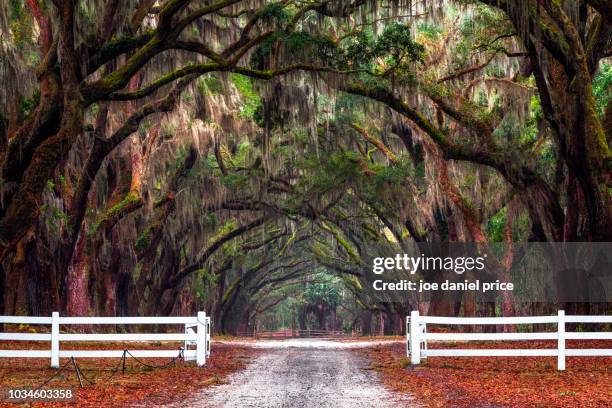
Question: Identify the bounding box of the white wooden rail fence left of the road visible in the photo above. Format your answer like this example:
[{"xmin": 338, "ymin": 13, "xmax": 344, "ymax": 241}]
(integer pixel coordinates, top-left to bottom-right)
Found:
[{"xmin": 0, "ymin": 312, "xmax": 211, "ymax": 367}]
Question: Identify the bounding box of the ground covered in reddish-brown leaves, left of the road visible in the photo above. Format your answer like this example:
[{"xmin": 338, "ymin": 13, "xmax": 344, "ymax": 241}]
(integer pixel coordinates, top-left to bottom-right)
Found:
[{"xmin": 0, "ymin": 343, "xmax": 261, "ymax": 407}]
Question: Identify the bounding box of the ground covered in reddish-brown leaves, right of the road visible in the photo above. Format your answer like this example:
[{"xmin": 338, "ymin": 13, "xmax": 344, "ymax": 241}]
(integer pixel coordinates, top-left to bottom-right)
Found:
[{"xmin": 370, "ymin": 341, "xmax": 612, "ymax": 407}]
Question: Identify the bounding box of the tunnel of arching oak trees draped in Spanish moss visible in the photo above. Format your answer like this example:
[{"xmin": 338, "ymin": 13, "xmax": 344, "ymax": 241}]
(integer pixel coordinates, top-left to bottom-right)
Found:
[{"xmin": 0, "ymin": 0, "xmax": 612, "ymax": 335}]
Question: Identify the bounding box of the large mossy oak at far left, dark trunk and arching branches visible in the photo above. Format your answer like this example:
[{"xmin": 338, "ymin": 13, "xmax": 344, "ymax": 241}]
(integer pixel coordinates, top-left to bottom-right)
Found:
[{"xmin": 0, "ymin": 1, "xmax": 368, "ymax": 316}]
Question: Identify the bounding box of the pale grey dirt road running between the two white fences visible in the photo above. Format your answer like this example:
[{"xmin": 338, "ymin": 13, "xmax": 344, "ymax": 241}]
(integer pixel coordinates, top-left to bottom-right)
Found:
[{"xmin": 169, "ymin": 341, "xmax": 416, "ymax": 408}]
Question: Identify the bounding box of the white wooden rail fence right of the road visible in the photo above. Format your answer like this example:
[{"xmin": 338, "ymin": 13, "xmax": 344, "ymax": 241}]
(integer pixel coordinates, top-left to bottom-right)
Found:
[{"xmin": 406, "ymin": 310, "xmax": 612, "ymax": 370}]
